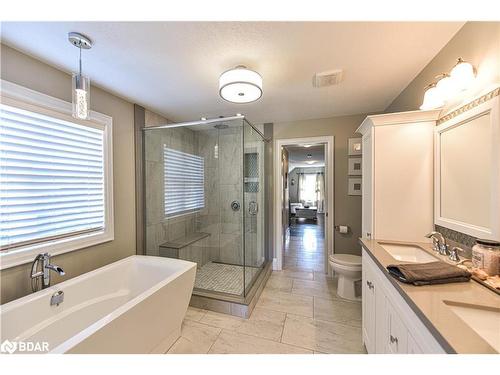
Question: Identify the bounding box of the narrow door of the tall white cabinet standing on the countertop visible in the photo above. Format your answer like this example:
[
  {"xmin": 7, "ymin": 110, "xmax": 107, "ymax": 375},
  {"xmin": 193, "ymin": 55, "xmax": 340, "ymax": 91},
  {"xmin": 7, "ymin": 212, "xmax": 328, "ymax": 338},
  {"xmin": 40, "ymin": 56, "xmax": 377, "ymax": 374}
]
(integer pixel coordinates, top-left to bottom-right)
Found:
[{"xmin": 361, "ymin": 130, "xmax": 373, "ymax": 239}]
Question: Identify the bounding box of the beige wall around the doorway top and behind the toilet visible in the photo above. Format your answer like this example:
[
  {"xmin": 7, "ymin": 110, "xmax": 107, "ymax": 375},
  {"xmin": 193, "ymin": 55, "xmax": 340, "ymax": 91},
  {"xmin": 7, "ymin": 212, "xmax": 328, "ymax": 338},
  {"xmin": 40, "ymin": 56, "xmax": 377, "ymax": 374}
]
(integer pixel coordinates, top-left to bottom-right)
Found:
[{"xmin": 273, "ymin": 115, "xmax": 366, "ymax": 254}]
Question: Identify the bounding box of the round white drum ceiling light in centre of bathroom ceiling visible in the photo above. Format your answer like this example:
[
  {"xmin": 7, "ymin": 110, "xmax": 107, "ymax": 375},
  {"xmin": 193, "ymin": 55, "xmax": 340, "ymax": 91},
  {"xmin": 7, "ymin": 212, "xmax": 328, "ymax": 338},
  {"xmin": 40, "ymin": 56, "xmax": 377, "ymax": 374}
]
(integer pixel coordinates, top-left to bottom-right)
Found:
[{"xmin": 219, "ymin": 65, "xmax": 262, "ymax": 104}]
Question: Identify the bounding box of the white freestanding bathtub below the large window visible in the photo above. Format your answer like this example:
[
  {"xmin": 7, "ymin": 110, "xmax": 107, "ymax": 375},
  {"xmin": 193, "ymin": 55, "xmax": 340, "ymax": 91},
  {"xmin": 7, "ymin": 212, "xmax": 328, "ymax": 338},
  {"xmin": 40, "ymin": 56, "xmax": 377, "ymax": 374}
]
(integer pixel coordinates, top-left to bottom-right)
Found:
[{"xmin": 0, "ymin": 255, "xmax": 196, "ymax": 353}]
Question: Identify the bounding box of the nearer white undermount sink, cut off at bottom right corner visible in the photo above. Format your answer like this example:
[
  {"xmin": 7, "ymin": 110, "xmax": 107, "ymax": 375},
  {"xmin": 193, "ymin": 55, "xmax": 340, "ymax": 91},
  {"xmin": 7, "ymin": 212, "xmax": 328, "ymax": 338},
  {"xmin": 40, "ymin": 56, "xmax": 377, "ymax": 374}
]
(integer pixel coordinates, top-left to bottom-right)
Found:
[{"xmin": 444, "ymin": 301, "xmax": 500, "ymax": 352}]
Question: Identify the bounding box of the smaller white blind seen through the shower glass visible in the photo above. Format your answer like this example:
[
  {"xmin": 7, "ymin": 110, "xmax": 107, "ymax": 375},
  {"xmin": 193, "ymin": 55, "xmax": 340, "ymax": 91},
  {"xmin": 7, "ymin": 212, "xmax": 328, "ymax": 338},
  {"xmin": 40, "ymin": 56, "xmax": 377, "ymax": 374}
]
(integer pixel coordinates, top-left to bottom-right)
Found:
[{"xmin": 163, "ymin": 146, "xmax": 205, "ymax": 217}]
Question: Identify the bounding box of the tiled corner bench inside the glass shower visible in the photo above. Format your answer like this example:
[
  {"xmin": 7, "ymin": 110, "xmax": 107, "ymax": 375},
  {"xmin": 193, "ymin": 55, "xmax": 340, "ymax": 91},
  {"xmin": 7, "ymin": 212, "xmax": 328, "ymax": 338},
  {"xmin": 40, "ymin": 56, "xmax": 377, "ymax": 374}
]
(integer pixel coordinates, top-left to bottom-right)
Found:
[{"xmin": 159, "ymin": 232, "xmax": 210, "ymax": 268}]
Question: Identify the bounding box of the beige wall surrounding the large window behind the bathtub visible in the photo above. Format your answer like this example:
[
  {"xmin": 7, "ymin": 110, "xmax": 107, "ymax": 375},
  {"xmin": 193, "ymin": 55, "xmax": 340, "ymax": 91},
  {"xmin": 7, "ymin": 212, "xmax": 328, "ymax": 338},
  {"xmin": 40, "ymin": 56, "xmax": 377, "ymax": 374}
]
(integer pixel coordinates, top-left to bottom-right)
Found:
[{"xmin": 0, "ymin": 45, "xmax": 135, "ymax": 303}]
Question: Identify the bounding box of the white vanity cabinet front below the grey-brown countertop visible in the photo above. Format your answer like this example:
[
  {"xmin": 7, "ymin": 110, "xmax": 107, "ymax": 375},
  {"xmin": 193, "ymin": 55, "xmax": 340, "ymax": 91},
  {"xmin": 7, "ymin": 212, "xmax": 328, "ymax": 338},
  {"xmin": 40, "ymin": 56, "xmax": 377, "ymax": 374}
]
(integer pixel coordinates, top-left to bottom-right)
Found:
[{"xmin": 362, "ymin": 249, "xmax": 445, "ymax": 354}]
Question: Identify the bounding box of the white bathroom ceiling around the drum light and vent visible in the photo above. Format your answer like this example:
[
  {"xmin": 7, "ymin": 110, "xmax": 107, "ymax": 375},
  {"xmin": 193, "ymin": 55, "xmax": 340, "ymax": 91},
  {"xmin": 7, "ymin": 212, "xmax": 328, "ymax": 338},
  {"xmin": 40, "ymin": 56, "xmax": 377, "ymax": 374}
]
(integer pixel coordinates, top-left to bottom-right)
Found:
[{"xmin": 2, "ymin": 22, "xmax": 463, "ymax": 123}]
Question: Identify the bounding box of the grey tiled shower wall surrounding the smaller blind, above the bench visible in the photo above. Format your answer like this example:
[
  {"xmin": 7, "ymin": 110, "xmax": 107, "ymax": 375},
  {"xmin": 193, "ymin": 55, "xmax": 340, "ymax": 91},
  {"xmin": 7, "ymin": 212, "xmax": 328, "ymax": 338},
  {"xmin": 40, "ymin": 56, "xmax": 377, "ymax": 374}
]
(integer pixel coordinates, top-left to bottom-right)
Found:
[{"xmin": 145, "ymin": 128, "xmax": 199, "ymax": 260}]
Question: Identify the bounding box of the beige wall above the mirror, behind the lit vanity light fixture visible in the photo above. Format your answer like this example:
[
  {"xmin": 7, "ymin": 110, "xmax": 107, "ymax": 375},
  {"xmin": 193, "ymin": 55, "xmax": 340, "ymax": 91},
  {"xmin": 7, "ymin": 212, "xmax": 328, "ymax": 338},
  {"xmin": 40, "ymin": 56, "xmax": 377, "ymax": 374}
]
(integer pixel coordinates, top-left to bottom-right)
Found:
[{"xmin": 385, "ymin": 22, "xmax": 500, "ymax": 112}]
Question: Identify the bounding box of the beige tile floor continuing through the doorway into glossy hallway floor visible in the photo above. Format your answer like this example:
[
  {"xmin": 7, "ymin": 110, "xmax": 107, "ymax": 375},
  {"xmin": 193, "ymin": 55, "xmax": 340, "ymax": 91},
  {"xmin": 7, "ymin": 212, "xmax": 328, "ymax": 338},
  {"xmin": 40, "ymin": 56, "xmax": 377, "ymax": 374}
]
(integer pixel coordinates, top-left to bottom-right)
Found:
[{"xmin": 168, "ymin": 219, "xmax": 366, "ymax": 354}]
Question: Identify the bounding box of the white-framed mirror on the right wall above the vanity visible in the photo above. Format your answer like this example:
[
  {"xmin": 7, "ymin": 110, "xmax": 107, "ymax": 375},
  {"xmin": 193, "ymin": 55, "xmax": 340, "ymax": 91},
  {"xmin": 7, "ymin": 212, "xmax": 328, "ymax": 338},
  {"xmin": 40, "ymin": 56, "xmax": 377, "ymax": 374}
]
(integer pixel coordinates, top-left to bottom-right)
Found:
[{"xmin": 434, "ymin": 96, "xmax": 500, "ymax": 240}]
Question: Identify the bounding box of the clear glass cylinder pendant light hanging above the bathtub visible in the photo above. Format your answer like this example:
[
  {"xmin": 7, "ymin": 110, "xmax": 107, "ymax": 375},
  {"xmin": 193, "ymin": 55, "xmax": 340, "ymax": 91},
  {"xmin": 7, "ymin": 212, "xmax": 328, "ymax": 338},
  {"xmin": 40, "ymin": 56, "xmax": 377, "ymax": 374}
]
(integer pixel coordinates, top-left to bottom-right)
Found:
[{"xmin": 68, "ymin": 32, "xmax": 92, "ymax": 120}]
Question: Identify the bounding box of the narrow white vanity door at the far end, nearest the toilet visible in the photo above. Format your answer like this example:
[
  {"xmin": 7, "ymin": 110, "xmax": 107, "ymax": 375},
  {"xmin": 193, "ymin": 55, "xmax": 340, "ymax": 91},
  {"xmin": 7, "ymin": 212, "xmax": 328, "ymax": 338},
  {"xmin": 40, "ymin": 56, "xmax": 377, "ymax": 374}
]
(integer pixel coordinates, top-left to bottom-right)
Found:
[{"xmin": 362, "ymin": 255, "xmax": 376, "ymax": 353}]
